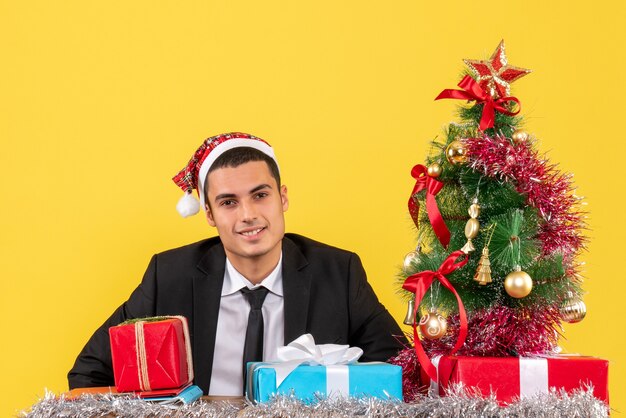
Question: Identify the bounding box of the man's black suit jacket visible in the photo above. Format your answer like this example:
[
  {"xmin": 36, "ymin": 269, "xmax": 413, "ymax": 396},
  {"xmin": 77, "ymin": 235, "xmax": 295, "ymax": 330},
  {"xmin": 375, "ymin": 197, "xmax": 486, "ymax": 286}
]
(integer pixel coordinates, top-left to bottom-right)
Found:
[{"xmin": 68, "ymin": 234, "xmax": 406, "ymax": 394}]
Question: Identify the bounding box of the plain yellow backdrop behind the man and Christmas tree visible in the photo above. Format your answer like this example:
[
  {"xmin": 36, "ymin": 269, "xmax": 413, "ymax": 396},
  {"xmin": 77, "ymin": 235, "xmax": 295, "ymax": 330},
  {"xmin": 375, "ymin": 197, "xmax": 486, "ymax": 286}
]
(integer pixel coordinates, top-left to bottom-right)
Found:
[{"xmin": 0, "ymin": 0, "xmax": 626, "ymax": 416}]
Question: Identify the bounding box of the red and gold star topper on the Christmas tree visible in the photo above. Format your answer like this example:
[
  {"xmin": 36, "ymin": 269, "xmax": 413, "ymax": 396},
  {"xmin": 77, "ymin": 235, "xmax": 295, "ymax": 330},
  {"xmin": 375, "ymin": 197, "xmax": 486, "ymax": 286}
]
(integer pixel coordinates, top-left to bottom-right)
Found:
[{"xmin": 463, "ymin": 40, "xmax": 531, "ymax": 99}]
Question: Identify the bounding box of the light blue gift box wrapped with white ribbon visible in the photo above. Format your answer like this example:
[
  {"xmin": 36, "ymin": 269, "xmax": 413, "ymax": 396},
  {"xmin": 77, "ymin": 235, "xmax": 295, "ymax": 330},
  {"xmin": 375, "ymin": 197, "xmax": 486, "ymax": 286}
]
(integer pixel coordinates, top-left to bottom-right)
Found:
[{"xmin": 246, "ymin": 362, "xmax": 402, "ymax": 403}]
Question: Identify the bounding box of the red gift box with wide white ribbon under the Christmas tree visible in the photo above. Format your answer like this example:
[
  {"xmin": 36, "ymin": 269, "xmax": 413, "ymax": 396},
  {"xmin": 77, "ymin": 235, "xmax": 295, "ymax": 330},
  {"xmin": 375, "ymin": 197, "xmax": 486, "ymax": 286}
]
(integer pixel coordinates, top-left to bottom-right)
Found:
[{"xmin": 422, "ymin": 356, "xmax": 609, "ymax": 404}]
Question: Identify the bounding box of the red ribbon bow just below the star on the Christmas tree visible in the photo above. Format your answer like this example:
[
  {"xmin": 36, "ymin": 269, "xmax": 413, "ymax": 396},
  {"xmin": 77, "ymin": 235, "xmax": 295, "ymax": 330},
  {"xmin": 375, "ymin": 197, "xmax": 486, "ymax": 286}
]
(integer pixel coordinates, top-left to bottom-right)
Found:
[{"xmin": 435, "ymin": 75, "xmax": 521, "ymax": 131}]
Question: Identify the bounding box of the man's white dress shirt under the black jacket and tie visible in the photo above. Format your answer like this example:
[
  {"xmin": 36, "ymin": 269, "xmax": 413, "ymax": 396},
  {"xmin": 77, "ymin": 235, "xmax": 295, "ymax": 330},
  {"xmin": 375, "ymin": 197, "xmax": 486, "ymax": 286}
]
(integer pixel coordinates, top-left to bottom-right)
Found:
[{"xmin": 209, "ymin": 254, "xmax": 285, "ymax": 396}]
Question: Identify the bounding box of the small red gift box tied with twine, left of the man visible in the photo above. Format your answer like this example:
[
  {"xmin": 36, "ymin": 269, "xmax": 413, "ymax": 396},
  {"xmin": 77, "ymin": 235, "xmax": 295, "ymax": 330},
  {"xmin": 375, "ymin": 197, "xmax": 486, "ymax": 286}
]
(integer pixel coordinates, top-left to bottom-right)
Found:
[{"xmin": 109, "ymin": 316, "xmax": 193, "ymax": 392}]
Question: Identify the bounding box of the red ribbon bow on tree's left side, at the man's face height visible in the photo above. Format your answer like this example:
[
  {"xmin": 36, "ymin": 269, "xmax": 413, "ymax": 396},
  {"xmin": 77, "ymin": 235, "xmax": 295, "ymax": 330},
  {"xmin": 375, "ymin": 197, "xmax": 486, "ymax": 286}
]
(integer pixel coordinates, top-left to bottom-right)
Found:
[{"xmin": 409, "ymin": 164, "xmax": 450, "ymax": 248}]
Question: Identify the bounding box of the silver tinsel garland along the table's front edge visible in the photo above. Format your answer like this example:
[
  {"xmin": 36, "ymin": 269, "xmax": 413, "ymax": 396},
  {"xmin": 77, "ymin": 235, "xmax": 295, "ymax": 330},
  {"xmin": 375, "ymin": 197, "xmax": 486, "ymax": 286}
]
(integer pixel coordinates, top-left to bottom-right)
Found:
[{"xmin": 21, "ymin": 386, "xmax": 609, "ymax": 418}]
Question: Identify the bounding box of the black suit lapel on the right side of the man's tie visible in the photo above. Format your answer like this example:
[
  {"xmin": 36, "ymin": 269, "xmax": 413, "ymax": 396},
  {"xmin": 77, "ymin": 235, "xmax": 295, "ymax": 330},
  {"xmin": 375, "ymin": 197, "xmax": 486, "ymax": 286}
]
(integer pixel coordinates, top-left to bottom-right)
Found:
[{"xmin": 283, "ymin": 237, "xmax": 311, "ymax": 345}]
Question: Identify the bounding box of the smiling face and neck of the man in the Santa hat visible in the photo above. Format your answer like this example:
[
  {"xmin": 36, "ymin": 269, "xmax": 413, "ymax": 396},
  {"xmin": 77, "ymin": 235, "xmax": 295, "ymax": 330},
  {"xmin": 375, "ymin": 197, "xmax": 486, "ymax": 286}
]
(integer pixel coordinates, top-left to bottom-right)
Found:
[{"xmin": 205, "ymin": 161, "xmax": 289, "ymax": 263}]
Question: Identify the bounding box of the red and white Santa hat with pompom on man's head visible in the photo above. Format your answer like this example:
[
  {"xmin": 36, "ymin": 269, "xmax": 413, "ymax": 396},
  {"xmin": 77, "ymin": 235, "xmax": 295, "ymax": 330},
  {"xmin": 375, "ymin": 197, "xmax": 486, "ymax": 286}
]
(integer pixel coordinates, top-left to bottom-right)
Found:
[{"xmin": 172, "ymin": 132, "xmax": 278, "ymax": 218}]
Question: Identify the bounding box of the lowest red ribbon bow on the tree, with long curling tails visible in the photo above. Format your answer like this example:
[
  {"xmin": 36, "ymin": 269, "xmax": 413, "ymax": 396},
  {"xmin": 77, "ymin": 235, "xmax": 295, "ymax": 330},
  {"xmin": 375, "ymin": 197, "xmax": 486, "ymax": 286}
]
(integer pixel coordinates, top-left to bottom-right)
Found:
[{"xmin": 402, "ymin": 250, "xmax": 468, "ymax": 381}]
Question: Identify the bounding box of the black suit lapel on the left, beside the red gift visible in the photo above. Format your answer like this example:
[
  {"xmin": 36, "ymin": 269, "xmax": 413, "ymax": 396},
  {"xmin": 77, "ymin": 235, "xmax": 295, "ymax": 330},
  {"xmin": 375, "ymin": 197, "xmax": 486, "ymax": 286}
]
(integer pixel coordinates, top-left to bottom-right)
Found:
[{"xmin": 193, "ymin": 243, "xmax": 226, "ymax": 393}]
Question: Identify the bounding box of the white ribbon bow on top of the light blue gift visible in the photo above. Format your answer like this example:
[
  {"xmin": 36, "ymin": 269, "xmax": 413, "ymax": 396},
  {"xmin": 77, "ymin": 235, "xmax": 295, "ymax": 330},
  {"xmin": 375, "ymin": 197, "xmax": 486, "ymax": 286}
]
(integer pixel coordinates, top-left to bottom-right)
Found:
[{"xmin": 272, "ymin": 334, "xmax": 363, "ymax": 388}]
